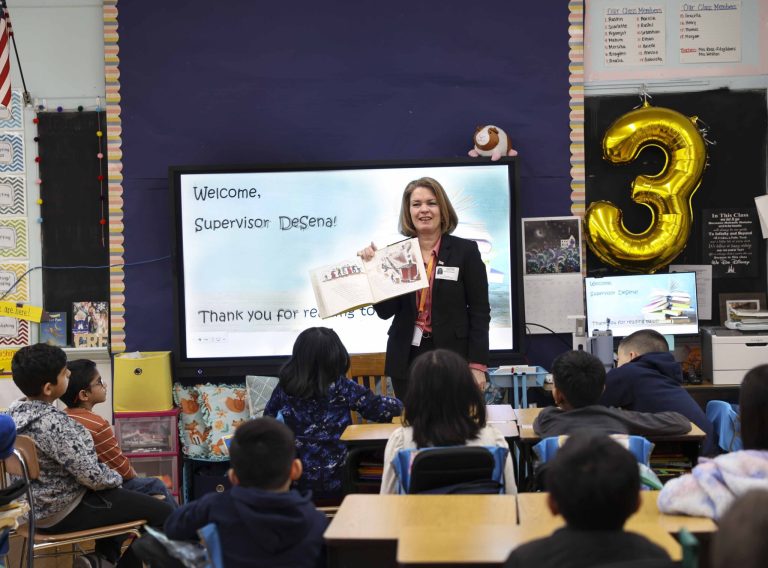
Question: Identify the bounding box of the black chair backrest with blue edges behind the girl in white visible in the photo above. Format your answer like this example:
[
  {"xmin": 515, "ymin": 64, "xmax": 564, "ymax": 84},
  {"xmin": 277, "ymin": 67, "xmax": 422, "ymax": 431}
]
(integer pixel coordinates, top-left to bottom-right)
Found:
[{"xmin": 392, "ymin": 446, "xmax": 509, "ymax": 493}]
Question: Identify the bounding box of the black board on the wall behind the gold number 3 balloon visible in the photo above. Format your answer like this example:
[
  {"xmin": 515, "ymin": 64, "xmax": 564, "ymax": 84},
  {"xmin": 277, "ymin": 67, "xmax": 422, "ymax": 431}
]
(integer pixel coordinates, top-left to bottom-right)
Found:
[{"xmin": 585, "ymin": 89, "xmax": 768, "ymax": 322}]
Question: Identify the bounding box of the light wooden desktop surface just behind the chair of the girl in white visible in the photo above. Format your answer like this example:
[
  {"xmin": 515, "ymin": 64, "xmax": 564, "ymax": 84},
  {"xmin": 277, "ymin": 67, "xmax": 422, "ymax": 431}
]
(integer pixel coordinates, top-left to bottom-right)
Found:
[{"xmin": 325, "ymin": 494, "xmax": 517, "ymax": 543}]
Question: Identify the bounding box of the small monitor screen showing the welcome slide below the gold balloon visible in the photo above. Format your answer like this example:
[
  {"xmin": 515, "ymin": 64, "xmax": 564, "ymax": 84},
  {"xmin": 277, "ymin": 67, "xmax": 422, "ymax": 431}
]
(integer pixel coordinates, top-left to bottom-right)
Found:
[{"xmin": 584, "ymin": 272, "xmax": 699, "ymax": 337}]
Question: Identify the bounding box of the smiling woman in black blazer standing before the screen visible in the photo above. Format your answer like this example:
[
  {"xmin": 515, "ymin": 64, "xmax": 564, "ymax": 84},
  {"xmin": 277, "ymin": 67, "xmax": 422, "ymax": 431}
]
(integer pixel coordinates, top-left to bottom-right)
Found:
[{"xmin": 358, "ymin": 177, "xmax": 491, "ymax": 398}]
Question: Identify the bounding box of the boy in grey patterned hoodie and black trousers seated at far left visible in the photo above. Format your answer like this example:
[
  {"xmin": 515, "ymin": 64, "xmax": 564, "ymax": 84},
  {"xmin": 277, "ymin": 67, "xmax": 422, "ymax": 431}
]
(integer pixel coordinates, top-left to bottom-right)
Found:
[{"xmin": 8, "ymin": 343, "xmax": 172, "ymax": 567}]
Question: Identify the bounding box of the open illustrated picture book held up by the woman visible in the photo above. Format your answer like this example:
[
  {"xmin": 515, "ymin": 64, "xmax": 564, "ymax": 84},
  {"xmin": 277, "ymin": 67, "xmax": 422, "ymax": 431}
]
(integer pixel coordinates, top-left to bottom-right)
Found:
[{"xmin": 309, "ymin": 238, "xmax": 429, "ymax": 318}]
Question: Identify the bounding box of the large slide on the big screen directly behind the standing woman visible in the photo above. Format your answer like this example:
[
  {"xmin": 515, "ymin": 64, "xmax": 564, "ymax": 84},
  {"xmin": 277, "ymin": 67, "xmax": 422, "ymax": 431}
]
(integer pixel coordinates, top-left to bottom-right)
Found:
[{"xmin": 177, "ymin": 165, "xmax": 517, "ymax": 358}]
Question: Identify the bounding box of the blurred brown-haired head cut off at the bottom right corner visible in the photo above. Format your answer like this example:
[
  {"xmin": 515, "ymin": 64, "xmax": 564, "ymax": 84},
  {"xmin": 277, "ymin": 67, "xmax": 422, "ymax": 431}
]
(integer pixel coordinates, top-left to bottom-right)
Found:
[{"xmin": 712, "ymin": 489, "xmax": 768, "ymax": 568}]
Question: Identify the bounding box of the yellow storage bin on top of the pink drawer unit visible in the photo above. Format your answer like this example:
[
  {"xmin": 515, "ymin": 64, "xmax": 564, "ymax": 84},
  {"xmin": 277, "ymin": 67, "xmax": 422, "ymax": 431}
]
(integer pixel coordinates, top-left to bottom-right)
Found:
[{"xmin": 112, "ymin": 351, "xmax": 173, "ymax": 412}]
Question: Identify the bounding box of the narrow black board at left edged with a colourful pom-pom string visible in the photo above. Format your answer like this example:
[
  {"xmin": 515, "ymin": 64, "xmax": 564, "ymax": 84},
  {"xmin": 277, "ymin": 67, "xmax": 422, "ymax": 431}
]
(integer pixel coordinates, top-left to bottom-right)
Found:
[{"xmin": 37, "ymin": 111, "xmax": 109, "ymax": 339}]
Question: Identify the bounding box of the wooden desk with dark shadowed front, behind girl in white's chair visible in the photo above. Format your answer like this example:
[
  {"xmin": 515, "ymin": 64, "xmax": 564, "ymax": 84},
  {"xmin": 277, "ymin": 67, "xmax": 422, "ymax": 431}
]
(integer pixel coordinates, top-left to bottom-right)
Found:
[{"xmin": 325, "ymin": 494, "xmax": 517, "ymax": 568}]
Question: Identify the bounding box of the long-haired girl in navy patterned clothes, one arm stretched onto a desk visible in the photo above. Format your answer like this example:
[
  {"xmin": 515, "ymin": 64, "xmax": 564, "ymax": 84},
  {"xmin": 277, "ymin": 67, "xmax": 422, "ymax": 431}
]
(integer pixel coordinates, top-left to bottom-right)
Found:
[{"xmin": 264, "ymin": 327, "xmax": 403, "ymax": 501}]
